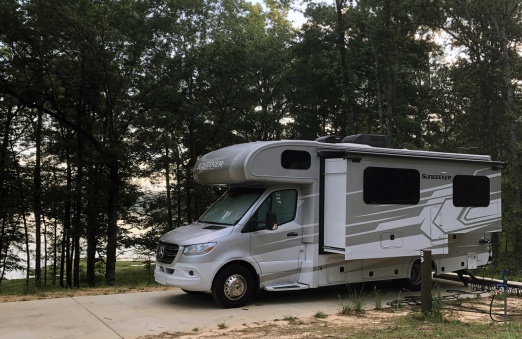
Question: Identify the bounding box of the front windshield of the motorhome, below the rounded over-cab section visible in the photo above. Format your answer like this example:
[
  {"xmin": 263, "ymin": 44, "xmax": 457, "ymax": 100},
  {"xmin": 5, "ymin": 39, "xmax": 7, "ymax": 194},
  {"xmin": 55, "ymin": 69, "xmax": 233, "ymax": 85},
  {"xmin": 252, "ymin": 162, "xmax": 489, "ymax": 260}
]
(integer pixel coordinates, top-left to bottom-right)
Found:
[{"xmin": 199, "ymin": 187, "xmax": 265, "ymax": 225}]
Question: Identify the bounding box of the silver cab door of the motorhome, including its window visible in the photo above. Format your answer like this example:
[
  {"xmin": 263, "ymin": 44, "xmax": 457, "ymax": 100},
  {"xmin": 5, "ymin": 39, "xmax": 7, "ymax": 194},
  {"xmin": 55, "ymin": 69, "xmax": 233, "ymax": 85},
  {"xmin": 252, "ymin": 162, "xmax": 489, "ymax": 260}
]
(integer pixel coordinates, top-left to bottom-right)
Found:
[{"xmin": 246, "ymin": 188, "xmax": 302, "ymax": 286}]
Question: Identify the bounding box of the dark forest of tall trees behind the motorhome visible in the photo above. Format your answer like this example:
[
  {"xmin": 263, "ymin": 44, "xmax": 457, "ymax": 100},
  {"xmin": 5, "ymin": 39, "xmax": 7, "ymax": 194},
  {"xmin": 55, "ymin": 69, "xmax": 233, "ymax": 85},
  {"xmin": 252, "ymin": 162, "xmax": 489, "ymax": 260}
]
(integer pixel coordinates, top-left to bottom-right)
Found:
[{"xmin": 0, "ymin": 0, "xmax": 522, "ymax": 287}]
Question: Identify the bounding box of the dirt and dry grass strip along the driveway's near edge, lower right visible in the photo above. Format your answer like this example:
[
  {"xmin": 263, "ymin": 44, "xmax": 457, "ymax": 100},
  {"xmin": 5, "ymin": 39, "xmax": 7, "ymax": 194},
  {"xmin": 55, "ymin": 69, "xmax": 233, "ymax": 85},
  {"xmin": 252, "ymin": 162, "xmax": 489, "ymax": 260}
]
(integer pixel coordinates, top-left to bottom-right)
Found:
[{"xmin": 136, "ymin": 298, "xmax": 522, "ymax": 339}]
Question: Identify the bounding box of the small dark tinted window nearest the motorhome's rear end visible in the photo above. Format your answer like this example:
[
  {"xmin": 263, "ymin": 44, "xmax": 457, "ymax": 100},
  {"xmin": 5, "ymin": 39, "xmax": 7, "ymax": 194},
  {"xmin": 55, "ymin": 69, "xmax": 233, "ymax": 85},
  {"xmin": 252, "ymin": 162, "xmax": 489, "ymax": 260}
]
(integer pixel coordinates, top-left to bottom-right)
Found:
[{"xmin": 453, "ymin": 175, "xmax": 489, "ymax": 207}]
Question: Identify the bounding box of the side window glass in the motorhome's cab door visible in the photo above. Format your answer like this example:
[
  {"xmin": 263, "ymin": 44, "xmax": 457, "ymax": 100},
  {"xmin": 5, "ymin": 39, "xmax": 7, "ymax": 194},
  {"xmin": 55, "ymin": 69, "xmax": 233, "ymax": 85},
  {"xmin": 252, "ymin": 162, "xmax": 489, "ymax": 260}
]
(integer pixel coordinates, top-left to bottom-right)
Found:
[{"xmin": 246, "ymin": 190, "xmax": 297, "ymax": 231}]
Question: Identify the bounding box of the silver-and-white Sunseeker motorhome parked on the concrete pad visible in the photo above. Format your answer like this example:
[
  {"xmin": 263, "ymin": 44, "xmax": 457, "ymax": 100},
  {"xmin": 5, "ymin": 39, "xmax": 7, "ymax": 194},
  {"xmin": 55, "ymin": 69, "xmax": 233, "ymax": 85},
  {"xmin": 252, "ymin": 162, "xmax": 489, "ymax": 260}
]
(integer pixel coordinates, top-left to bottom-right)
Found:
[{"xmin": 154, "ymin": 135, "xmax": 503, "ymax": 308}]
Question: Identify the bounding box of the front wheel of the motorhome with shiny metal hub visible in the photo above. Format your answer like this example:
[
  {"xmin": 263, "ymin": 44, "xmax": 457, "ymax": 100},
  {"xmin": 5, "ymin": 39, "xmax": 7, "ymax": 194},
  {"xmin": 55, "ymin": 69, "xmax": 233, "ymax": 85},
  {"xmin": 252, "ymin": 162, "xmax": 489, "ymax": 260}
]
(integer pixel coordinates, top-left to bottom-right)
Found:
[{"xmin": 212, "ymin": 265, "xmax": 254, "ymax": 308}]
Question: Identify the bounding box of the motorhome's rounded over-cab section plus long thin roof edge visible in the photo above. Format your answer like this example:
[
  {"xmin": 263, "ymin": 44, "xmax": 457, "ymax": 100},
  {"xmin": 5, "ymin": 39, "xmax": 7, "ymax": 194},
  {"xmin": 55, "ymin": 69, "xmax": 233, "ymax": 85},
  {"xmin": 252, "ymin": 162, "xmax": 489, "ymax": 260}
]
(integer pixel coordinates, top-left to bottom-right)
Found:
[{"xmin": 194, "ymin": 140, "xmax": 504, "ymax": 184}]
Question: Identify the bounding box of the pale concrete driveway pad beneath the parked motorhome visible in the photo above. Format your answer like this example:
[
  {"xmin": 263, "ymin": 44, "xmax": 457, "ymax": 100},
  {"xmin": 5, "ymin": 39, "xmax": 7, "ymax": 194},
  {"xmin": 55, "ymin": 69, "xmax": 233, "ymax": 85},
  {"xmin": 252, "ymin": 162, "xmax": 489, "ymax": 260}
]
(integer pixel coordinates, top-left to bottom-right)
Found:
[{"xmin": 0, "ymin": 280, "xmax": 488, "ymax": 339}]
